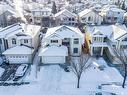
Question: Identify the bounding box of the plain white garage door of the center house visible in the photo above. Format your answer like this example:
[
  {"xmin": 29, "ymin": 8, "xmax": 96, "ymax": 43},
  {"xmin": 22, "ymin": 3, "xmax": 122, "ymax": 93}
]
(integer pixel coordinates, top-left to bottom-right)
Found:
[{"xmin": 42, "ymin": 56, "xmax": 65, "ymax": 64}]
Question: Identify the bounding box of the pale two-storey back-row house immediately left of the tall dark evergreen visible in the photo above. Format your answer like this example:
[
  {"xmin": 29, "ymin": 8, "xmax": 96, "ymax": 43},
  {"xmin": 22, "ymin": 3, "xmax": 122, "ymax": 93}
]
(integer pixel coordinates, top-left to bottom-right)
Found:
[{"xmin": 31, "ymin": 7, "xmax": 52, "ymax": 27}]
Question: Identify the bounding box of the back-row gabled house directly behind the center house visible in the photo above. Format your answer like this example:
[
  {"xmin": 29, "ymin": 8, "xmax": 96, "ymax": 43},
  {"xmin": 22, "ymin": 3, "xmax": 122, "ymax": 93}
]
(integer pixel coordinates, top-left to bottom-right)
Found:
[{"xmin": 55, "ymin": 9, "xmax": 77, "ymax": 26}]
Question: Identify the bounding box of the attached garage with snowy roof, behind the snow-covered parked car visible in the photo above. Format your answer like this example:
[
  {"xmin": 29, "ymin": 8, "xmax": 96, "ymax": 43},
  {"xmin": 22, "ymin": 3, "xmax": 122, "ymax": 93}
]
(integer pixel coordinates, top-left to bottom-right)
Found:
[{"xmin": 3, "ymin": 46, "xmax": 33, "ymax": 64}]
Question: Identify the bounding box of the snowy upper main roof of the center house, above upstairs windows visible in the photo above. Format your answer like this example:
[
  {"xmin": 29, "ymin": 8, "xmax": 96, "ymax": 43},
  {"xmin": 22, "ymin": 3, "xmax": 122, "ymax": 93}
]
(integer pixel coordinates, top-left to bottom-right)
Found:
[{"xmin": 44, "ymin": 25, "xmax": 84, "ymax": 39}]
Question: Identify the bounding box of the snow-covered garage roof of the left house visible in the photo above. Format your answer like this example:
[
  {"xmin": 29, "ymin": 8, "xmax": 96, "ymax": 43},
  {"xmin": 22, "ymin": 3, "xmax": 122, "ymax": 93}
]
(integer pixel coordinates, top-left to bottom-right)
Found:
[{"xmin": 2, "ymin": 46, "xmax": 33, "ymax": 55}]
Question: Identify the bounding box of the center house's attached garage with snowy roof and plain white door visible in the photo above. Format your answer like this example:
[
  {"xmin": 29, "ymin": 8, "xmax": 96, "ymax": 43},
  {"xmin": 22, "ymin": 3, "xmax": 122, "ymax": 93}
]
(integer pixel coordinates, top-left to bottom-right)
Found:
[{"xmin": 39, "ymin": 46, "xmax": 68, "ymax": 64}]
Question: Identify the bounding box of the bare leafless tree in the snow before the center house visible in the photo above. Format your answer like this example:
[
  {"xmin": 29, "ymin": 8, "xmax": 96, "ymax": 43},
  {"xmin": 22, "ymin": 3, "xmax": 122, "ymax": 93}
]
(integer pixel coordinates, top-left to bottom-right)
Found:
[{"xmin": 70, "ymin": 54, "xmax": 91, "ymax": 88}]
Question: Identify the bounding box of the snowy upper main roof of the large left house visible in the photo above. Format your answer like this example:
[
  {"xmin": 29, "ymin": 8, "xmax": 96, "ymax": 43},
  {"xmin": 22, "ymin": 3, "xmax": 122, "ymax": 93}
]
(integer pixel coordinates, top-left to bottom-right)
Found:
[{"xmin": 0, "ymin": 23, "xmax": 40, "ymax": 38}]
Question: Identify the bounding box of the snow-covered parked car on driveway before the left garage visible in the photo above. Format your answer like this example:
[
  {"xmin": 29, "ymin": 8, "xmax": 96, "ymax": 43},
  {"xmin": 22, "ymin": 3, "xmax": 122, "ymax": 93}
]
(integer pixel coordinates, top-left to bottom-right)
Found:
[{"xmin": 15, "ymin": 64, "xmax": 28, "ymax": 76}]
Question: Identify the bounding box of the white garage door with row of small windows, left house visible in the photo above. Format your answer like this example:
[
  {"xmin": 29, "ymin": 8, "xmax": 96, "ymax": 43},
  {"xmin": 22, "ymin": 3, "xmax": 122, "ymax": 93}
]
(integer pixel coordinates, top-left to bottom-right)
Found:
[{"xmin": 9, "ymin": 56, "xmax": 28, "ymax": 64}]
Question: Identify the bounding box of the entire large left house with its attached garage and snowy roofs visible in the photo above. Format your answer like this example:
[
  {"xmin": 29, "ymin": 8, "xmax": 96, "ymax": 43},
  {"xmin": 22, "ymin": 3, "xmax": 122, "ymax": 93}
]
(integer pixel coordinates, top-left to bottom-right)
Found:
[{"xmin": 0, "ymin": 24, "xmax": 40, "ymax": 64}]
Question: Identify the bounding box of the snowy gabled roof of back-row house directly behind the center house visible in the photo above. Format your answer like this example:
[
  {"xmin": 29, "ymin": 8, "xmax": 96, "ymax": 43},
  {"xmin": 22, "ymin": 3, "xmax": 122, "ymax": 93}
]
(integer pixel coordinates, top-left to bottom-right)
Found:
[{"xmin": 55, "ymin": 9, "xmax": 76, "ymax": 17}]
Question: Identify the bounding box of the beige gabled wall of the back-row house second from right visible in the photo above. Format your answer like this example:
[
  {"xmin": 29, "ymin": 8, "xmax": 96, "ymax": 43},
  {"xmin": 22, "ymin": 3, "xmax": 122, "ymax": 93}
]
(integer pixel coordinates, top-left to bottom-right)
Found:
[{"xmin": 80, "ymin": 12, "xmax": 103, "ymax": 25}]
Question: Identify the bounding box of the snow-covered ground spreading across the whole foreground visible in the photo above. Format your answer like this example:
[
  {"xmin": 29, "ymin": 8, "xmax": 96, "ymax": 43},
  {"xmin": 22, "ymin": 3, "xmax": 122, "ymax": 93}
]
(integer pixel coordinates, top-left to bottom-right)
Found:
[{"xmin": 0, "ymin": 58, "xmax": 127, "ymax": 95}]
